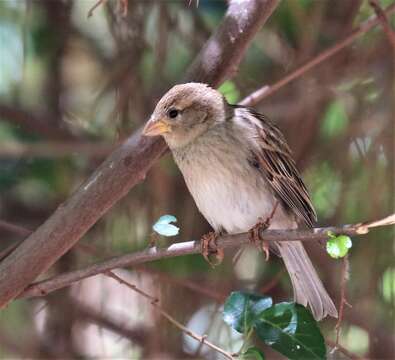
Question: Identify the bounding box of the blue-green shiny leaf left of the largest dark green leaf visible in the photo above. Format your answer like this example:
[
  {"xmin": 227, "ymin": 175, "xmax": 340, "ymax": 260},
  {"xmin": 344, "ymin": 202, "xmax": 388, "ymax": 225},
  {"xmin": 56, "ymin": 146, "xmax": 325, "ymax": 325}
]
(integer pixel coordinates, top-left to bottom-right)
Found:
[{"xmin": 223, "ymin": 291, "xmax": 273, "ymax": 333}]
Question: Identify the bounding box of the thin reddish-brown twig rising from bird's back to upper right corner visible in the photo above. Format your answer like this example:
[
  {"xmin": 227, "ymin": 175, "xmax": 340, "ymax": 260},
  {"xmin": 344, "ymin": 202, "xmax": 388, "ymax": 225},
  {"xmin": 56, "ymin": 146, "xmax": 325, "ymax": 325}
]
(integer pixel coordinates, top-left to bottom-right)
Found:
[{"xmin": 239, "ymin": 4, "xmax": 395, "ymax": 106}]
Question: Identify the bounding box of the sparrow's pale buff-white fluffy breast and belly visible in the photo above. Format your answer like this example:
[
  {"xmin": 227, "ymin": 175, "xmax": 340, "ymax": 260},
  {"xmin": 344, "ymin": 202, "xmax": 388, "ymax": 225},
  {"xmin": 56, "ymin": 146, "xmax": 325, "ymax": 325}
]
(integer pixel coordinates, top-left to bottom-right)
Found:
[{"xmin": 173, "ymin": 134, "xmax": 288, "ymax": 233}]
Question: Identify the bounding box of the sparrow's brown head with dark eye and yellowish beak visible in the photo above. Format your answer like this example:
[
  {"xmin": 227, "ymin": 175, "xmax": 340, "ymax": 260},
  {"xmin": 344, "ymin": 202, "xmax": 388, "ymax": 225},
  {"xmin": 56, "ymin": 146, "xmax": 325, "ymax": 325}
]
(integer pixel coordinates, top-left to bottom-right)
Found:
[{"xmin": 143, "ymin": 83, "xmax": 227, "ymax": 149}]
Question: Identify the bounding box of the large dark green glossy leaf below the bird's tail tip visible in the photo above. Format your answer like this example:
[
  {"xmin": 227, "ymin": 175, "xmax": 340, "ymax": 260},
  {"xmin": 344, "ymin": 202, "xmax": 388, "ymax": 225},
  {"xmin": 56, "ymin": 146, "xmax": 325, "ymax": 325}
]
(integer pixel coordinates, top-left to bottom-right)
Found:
[{"xmin": 254, "ymin": 302, "xmax": 326, "ymax": 360}]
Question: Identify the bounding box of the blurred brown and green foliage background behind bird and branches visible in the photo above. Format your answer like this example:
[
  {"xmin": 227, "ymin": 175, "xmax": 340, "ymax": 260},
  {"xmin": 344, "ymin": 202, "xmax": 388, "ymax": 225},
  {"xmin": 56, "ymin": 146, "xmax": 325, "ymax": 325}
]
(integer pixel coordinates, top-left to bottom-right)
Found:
[{"xmin": 0, "ymin": 0, "xmax": 395, "ymax": 359}]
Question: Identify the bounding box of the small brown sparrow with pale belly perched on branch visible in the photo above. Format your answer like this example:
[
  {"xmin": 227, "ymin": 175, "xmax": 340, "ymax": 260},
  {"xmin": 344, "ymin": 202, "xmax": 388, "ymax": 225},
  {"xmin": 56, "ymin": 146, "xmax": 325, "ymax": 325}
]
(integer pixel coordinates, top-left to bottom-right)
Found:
[{"xmin": 143, "ymin": 82, "xmax": 338, "ymax": 320}]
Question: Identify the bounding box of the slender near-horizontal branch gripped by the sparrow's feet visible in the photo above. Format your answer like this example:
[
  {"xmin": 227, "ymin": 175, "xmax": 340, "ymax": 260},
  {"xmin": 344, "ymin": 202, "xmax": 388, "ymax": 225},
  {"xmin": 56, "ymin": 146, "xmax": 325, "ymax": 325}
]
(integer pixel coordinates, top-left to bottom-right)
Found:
[{"xmin": 20, "ymin": 214, "xmax": 395, "ymax": 298}]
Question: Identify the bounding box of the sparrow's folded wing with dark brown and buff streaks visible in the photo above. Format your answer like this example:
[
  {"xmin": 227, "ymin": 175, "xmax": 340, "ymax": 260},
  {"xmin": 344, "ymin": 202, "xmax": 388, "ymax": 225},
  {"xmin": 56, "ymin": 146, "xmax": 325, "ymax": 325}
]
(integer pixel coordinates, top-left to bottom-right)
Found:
[{"xmin": 237, "ymin": 108, "xmax": 317, "ymax": 227}]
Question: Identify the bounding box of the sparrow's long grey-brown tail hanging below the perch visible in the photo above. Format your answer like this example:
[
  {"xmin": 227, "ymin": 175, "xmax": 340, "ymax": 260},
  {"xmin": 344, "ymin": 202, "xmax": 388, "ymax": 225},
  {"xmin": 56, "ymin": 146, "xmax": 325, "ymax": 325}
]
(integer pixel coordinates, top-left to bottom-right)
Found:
[{"xmin": 277, "ymin": 241, "xmax": 338, "ymax": 320}]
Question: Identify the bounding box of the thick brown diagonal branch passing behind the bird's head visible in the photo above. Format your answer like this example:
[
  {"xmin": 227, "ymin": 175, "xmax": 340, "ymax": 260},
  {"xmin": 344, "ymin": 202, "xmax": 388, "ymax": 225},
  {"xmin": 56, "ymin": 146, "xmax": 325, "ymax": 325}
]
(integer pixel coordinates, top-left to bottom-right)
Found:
[{"xmin": 0, "ymin": 0, "xmax": 279, "ymax": 307}]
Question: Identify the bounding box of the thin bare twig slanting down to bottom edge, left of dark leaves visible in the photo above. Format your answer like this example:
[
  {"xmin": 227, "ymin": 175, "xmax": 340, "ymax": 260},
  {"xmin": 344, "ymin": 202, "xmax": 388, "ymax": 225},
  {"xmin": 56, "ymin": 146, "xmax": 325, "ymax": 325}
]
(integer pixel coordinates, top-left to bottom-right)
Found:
[{"xmin": 105, "ymin": 271, "xmax": 233, "ymax": 359}]
